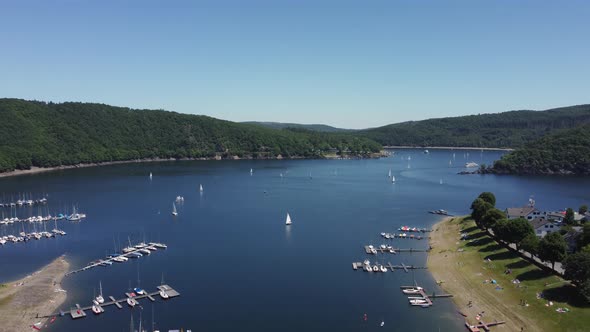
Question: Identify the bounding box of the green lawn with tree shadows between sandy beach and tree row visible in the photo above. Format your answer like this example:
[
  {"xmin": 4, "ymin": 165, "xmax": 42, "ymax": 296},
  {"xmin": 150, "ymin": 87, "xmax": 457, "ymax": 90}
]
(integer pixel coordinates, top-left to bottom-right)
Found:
[{"xmin": 452, "ymin": 218, "xmax": 590, "ymax": 331}]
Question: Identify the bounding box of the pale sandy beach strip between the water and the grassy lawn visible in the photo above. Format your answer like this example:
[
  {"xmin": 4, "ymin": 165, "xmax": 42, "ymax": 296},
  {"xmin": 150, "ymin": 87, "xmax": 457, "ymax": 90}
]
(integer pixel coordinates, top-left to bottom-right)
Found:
[{"xmin": 427, "ymin": 217, "xmax": 543, "ymax": 331}]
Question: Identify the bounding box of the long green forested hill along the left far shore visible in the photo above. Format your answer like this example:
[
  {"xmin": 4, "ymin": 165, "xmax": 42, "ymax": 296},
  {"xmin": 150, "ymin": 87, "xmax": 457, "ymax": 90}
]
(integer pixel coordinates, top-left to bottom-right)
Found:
[{"xmin": 0, "ymin": 99, "xmax": 381, "ymax": 172}]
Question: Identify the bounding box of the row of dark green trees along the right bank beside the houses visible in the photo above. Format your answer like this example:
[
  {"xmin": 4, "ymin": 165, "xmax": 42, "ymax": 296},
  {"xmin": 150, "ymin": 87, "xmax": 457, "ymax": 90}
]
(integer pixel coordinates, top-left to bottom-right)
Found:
[{"xmin": 471, "ymin": 192, "xmax": 590, "ymax": 302}]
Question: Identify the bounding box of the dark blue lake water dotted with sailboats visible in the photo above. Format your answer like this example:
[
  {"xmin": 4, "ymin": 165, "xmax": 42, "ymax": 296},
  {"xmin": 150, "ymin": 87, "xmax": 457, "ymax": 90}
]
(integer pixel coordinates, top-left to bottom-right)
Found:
[{"xmin": 0, "ymin": 150, "xmax": 590, "ymax": 331}]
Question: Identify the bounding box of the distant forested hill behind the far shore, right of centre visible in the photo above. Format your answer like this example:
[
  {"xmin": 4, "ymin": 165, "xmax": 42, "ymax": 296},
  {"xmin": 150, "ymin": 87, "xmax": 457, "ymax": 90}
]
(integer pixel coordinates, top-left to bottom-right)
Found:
[{"xmin": 359, "ymin": 105, "xmax": 590, "ymax": 148}]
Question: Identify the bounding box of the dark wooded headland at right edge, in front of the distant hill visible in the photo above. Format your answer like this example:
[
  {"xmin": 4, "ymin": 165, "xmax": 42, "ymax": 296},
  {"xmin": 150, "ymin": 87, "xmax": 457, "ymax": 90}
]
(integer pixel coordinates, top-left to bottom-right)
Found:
[{"xmin": 493, "ymin": 125, "xmax": 590, "ymax": 175}]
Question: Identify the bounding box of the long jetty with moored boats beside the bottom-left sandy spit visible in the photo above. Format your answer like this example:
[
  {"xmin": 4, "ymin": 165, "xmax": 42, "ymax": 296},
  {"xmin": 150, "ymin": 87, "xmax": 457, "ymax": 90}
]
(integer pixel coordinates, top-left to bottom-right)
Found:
[{"xmin": 59, "ymin": 285, "xmax": 180, "ymax": 319}]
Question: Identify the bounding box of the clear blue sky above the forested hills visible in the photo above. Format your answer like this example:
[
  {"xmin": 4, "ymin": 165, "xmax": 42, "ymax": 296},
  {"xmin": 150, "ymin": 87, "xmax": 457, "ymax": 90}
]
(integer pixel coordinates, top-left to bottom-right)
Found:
[{"xmin": 0, "ymin": 0, "xmax": 590, "ymax": 128}]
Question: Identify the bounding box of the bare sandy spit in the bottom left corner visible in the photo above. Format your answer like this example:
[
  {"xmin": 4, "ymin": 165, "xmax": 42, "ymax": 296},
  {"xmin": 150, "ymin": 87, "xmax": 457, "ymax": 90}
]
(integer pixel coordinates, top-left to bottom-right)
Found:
[{"xmin": 0, "ymin": 256, "xmax": 69, "ymax": 332}]
